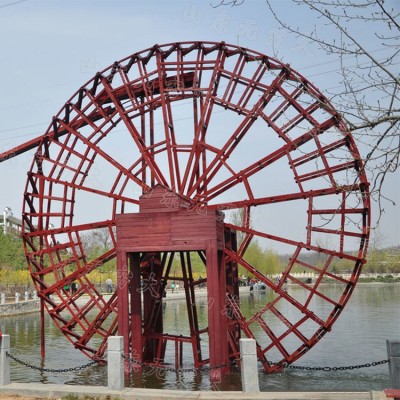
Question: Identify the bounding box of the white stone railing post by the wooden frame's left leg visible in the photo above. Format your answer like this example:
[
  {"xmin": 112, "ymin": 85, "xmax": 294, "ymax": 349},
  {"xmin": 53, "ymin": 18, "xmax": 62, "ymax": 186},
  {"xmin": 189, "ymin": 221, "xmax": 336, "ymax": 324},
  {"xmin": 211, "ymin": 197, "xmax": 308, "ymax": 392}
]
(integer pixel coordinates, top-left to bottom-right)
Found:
[{"xmin": 107, "ymin": 336, "xmax": 125, "ymax": 390}]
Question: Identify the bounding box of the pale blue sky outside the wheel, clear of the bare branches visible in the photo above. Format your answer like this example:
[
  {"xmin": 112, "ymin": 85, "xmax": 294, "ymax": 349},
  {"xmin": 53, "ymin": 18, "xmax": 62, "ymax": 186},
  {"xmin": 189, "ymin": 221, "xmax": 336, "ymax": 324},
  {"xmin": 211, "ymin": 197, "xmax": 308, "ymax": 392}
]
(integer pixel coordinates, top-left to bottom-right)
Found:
[{"xmin": 0, "ymin": 0, "xmax": 400, "ymax": 250}]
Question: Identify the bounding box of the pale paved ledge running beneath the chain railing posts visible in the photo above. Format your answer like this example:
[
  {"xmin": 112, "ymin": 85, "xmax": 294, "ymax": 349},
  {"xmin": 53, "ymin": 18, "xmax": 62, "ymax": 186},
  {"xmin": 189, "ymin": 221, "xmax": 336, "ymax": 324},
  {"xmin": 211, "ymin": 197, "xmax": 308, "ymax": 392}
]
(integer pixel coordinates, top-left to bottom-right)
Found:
[{"xmin": 0, "ymin": 383, "xmax": 386, "ymax": 400}]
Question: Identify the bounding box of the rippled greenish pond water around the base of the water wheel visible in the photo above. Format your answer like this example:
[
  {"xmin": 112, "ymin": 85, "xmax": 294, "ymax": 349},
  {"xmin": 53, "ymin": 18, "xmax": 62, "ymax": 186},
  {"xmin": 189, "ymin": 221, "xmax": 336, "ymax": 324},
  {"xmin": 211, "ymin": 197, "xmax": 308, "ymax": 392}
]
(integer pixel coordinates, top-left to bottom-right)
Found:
[{"xmin": 0, "ymin": 284, "xmax": 400, "ymax": 391}]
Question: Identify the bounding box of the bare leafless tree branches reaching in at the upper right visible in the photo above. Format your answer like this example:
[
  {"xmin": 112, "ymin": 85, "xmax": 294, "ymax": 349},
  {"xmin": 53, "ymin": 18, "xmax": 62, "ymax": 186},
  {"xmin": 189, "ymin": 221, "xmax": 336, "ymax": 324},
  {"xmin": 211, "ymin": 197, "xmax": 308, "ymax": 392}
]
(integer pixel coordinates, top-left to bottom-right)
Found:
[{"xmin": 212, "ymin": 0, "xmax": 400, "ymax": 222}]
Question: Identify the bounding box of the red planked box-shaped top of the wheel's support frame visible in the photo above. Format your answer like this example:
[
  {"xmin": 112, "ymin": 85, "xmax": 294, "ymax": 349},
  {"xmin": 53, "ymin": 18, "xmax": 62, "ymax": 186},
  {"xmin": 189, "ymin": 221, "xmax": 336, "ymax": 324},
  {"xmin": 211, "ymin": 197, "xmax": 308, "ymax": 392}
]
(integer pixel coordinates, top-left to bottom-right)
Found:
[{"xmin": 116, "ymin": 186, "xmax": 224, "ymax": 252}]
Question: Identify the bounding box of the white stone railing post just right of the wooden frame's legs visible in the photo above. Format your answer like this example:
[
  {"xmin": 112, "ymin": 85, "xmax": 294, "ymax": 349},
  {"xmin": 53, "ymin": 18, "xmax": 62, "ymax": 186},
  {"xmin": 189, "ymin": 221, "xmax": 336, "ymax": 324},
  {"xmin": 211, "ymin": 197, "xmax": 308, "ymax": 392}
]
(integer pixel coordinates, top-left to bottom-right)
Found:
[{"xmin": 239, "ymin": 339, "xmax": 260, "ymax": 393}]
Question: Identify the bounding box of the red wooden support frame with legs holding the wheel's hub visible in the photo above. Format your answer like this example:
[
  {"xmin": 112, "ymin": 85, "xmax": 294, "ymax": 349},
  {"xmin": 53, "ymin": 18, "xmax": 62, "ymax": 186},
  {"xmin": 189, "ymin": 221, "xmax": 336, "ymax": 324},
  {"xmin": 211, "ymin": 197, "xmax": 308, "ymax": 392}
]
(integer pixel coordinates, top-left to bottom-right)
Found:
[{"xmin": 116, "ymin": 185, "xmax": 228, "ymax": 380}]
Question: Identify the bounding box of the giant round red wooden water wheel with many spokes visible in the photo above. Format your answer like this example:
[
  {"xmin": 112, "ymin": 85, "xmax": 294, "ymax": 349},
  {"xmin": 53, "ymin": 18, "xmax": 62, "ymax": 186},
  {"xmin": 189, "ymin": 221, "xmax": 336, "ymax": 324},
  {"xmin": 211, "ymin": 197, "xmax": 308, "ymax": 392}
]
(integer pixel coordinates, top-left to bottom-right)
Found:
[{"xmin": 23, "ymin": 42, "xmax": 370, "ymax": 371}]
